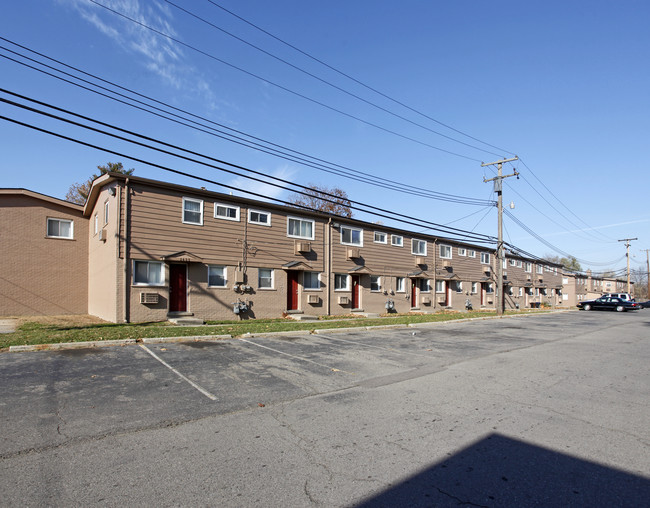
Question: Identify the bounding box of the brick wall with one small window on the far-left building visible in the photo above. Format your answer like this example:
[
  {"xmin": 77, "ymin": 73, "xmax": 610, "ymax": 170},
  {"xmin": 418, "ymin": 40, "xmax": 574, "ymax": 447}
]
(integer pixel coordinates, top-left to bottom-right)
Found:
[{"xmin": 0, "ymin": 189, "xmax": 88, "ymax": 316}]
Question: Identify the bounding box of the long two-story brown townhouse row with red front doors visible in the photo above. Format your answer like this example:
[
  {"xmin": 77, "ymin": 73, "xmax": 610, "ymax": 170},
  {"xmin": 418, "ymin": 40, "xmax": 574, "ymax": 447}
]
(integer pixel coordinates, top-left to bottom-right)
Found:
[{"xmin": 1, "ymin": 173, "xmax": 561, "ymax": 322}]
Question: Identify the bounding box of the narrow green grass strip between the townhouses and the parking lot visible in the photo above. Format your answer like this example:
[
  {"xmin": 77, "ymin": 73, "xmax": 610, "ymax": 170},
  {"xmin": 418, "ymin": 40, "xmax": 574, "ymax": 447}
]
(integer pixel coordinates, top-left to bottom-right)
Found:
[{"xmin": 0, "ymin": 311, "xmax": 544, "ymax": 350}]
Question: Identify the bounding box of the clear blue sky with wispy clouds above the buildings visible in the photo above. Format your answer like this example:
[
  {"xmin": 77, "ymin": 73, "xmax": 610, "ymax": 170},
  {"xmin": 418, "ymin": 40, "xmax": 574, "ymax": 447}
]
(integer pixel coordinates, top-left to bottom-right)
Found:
[{"xmin": 0, "ymin": 0, "xmax": 650, "ymax": 271}]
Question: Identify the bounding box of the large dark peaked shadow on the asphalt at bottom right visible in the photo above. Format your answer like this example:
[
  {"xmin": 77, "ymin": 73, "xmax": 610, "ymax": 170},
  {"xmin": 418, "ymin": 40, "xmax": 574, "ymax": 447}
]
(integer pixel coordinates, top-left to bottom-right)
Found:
[{"xmin": 355, "ymin": 434, "xmax": 650, "ymax": 508}]
